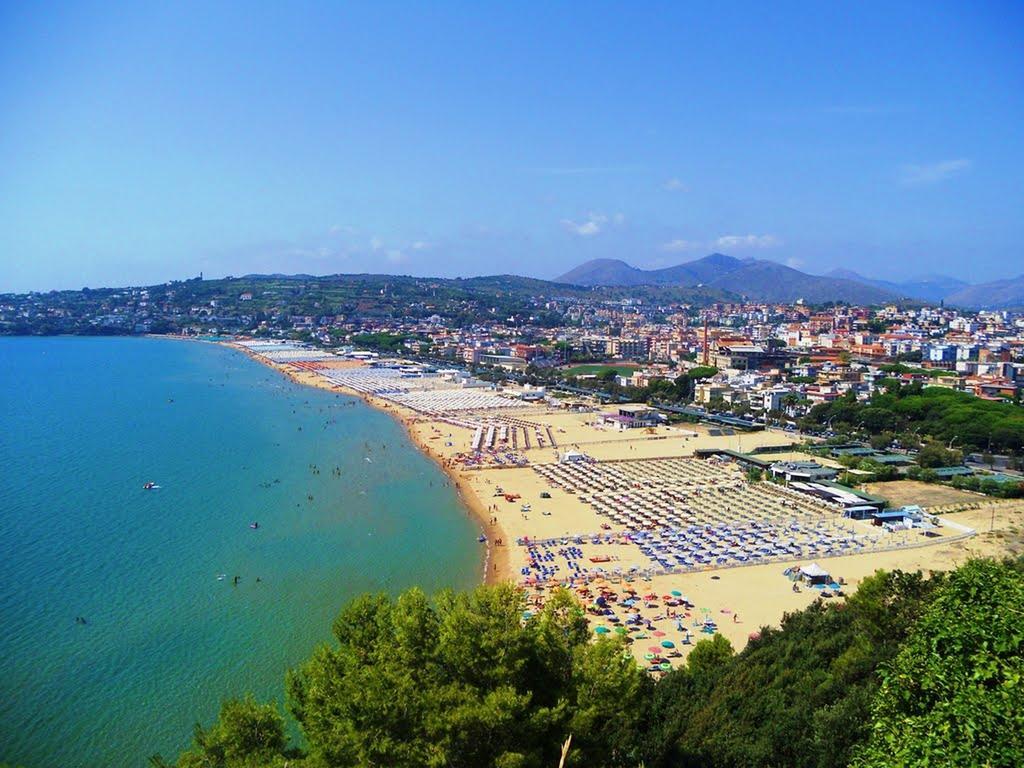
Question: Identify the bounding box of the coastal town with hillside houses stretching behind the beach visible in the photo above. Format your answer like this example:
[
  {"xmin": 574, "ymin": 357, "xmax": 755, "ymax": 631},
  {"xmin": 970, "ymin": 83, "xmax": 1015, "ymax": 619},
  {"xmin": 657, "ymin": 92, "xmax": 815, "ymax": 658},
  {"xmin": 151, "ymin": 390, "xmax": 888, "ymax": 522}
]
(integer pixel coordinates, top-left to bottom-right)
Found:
[{"xmin": 6, "ymin": 275, "xmax": 1024, "ymax": 421}]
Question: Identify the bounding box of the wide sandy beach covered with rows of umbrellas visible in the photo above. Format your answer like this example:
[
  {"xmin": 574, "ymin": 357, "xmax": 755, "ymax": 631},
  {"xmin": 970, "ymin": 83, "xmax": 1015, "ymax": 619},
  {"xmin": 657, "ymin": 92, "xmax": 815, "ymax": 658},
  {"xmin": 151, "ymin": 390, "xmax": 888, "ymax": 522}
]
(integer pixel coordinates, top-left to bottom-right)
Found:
[{"xmin": 231, "ymin": 345, "xmax": 1024, "ymax": 669}]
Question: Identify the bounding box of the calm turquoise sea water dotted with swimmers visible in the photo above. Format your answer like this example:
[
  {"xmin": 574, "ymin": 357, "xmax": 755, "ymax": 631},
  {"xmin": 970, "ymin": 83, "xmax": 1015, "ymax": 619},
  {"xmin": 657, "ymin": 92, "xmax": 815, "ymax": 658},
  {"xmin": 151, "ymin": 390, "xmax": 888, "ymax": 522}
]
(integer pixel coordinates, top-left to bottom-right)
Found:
[{"xmin": 0, "ymin": 338, "xmax": 482, "ymax": 768}]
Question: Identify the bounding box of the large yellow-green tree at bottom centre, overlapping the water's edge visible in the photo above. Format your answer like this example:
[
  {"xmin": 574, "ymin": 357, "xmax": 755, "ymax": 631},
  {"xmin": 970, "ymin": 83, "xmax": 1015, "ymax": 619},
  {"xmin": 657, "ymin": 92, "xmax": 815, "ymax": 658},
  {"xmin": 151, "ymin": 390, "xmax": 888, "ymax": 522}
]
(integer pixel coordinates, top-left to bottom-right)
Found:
[{"xmin": 280, "ymin": 585, "xmax": 650, "ymax": 768}]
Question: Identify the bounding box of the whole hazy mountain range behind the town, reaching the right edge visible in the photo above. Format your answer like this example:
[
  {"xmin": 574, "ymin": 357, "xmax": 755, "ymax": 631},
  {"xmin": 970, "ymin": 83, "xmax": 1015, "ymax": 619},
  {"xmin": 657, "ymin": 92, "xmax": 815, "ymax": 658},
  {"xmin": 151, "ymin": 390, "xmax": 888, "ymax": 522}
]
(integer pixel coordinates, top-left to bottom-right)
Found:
[{"xmin": 555, "ymin": 253, "xmax": 1024, "ymax": 309}]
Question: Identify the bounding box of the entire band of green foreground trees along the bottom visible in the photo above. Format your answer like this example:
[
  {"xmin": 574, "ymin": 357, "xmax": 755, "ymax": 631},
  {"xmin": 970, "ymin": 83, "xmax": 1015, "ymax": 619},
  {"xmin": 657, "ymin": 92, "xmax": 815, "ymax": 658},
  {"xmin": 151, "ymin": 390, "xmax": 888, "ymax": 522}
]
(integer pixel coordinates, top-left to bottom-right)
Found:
[{"xmin": 154, "ymin": 560, "xmax": 1024, "ymax": 768}]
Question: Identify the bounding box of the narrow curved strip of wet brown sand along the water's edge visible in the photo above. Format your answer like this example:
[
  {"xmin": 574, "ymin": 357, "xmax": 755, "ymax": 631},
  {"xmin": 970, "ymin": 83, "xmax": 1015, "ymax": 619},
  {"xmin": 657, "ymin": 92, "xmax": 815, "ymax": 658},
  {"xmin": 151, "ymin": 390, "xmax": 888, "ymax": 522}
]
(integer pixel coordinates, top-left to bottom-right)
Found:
[{"xmin": 225, "ymin": 341, "xmax": 513, "ymax": 585}]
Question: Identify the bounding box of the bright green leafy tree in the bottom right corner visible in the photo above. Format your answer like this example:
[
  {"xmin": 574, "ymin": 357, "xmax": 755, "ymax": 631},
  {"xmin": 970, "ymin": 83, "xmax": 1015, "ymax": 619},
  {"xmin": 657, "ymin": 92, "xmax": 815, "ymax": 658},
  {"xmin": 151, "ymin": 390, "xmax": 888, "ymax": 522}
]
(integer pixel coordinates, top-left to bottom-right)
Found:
[{"xmin": 855, "ymin": 560, "xmax": 1024, "ymax": 768}]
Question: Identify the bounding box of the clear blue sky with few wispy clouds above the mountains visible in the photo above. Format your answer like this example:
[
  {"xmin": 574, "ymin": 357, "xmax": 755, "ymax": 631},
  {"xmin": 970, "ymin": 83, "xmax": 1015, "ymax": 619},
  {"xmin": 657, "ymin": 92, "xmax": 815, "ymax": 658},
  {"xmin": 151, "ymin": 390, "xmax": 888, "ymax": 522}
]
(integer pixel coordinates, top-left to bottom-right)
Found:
[{"xmin": 0, "ymin": 2, "xmax": 1024, "ymax": 291}]
